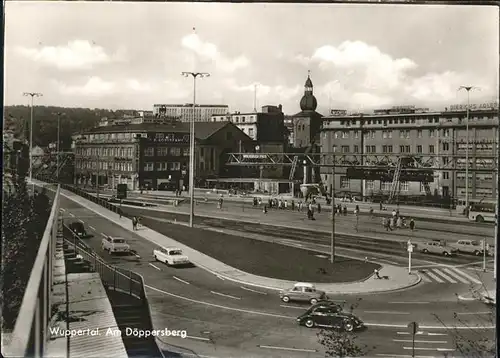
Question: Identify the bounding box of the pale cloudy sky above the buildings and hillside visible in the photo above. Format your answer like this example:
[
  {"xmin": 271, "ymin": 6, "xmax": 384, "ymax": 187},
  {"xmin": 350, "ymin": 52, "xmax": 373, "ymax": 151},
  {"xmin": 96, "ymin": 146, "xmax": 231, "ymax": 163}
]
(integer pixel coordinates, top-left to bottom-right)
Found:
[{"xmin": 4, "ymin": 1, "xmax": 499, "ymax": 114}]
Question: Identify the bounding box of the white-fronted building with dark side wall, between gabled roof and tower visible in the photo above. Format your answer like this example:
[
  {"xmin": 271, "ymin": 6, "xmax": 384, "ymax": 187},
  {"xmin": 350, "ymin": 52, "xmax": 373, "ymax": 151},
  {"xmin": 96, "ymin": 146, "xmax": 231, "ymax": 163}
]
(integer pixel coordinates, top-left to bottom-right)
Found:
[{"xmin": 212, "ymin": 104, "xmax": 286, "ymax": 143}]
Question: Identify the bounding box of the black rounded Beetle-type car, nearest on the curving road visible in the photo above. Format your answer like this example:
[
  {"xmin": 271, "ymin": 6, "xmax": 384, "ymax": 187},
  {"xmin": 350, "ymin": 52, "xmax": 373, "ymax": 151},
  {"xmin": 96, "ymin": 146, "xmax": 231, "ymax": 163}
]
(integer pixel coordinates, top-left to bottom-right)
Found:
[{"xmin": 297, "ymin": 304, "xmax": 365, "ymax": 332}]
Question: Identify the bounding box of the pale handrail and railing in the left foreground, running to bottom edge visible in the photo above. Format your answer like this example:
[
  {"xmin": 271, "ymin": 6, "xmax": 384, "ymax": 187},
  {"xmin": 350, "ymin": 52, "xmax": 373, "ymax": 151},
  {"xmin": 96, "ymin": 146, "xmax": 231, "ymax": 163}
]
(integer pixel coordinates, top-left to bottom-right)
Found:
[{"xmin": 3, "ymin": 185, "xmax": 60, "ymax": 357}]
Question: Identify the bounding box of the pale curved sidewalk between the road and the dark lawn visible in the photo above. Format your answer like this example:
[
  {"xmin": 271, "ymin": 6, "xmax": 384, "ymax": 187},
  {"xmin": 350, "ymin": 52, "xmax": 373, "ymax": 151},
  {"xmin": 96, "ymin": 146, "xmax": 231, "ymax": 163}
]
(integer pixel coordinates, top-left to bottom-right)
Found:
[{"xmin": 56, "ymin": 185, "xmax": 421, "ymax": 294}]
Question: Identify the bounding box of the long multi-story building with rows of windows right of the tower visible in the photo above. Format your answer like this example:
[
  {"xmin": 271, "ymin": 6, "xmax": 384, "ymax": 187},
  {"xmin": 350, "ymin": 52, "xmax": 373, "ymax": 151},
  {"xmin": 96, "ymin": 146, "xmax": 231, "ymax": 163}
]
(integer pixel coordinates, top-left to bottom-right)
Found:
[{"xmin": 321, "ymin": 104, "xmax": 499, "ymax": 198}]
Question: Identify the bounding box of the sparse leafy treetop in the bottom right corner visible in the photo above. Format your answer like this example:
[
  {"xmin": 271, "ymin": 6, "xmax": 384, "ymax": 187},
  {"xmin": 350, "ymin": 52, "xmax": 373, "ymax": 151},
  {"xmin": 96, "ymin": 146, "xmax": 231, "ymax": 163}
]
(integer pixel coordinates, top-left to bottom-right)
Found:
[{"xmin": 434, "ymin": 275, "xmax": 496, "ymax": 358}]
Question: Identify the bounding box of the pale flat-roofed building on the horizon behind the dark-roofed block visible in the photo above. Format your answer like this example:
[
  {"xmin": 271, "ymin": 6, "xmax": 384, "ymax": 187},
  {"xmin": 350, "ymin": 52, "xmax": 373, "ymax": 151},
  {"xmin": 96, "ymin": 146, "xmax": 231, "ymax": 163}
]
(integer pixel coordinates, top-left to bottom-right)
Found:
[{"xmin": 153, "ymin": 103, "xmax": 229, "ymax": 122}]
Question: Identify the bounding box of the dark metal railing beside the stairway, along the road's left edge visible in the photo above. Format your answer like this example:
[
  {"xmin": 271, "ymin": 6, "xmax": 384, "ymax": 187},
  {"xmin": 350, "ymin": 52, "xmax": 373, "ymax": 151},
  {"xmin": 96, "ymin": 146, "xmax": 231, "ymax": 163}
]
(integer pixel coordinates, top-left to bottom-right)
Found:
[{"xmin": 63, "ymin": 225, "xmax": 147, "ymax": 304}]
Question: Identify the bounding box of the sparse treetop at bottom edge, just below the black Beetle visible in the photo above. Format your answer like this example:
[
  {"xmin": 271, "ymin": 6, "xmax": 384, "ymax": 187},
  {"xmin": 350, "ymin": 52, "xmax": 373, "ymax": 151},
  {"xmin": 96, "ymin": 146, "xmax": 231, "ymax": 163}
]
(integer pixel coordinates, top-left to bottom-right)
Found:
[{"xmin": 317, "ymin": 299, "xmax": 368, "ymax": 358}]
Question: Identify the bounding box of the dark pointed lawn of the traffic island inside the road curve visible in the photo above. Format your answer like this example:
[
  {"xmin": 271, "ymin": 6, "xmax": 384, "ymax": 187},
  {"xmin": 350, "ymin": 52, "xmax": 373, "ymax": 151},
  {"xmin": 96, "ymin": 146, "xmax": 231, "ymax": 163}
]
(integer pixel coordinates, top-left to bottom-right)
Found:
[{"xmin": 137, "ymin": 217, "xmax": 381, "ymax": 283}]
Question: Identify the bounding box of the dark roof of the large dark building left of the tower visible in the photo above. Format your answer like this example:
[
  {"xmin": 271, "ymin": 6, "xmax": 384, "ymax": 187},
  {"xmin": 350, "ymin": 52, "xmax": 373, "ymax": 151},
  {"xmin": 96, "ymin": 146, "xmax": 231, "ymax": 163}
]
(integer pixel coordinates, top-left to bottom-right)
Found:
[{"xmin": 82, "ymin": 122, "xmax": 233, "ymax": 140}]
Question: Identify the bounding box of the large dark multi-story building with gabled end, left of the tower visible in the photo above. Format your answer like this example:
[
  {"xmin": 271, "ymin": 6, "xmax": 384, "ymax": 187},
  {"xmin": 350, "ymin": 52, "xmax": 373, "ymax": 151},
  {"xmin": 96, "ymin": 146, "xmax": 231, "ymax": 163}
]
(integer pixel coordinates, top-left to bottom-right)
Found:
[{"xmin": 74, "ymin": 122, "xmax": 252, "ymax": 190}]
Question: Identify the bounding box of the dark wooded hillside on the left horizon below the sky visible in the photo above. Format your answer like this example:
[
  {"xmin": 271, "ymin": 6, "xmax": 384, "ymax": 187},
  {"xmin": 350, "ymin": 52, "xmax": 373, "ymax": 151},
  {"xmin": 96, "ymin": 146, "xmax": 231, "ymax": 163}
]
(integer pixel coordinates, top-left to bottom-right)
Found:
[{"xmin": 4, "ymin": 106, "xmax": 135, "ymax": 150}]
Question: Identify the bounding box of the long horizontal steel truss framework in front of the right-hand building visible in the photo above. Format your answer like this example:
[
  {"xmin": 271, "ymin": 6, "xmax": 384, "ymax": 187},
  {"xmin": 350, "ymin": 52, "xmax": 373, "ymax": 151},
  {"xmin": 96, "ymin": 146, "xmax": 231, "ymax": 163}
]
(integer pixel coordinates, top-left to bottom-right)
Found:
[{"xmin": 226, "ymin": 153, "xmax": 498, "ymax": 173}]
